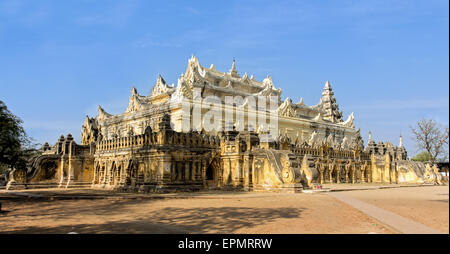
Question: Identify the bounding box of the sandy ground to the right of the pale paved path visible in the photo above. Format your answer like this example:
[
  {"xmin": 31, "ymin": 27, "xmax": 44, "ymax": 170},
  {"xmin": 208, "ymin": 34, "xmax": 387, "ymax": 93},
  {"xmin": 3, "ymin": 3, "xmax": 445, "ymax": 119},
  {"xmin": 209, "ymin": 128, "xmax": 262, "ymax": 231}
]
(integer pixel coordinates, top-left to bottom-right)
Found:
[{"xmin": 345, "ymin": 186, "xmax": 449, "ymax": 234}]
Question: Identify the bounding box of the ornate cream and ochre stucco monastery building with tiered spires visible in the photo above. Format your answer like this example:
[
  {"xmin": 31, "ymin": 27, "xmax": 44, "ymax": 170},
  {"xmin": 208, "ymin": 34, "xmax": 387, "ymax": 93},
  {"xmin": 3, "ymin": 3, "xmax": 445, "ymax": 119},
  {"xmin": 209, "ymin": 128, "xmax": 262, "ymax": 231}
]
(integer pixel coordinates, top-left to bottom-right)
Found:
[{"xmin": 9, "ymin": 56, "xmax": 442, "ymax": 192}]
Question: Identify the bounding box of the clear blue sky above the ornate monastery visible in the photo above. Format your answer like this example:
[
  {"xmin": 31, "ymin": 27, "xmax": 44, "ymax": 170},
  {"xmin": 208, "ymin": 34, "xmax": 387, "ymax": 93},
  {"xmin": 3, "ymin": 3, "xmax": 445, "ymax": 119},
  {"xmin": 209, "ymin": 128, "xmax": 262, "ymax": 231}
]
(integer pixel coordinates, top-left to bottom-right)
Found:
[{"xmin": 0, "ymin": 0, "xmax": 449, "ymax": 155}]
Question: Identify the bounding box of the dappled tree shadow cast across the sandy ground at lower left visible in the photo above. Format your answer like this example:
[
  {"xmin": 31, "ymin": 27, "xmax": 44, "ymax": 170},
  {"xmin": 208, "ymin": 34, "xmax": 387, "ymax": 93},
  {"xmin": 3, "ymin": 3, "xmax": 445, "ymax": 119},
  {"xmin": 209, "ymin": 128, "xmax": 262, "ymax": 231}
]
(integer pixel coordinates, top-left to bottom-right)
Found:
[{"xmin": 0, "ymin": 197, "xmax": 304, "ymax": 234}]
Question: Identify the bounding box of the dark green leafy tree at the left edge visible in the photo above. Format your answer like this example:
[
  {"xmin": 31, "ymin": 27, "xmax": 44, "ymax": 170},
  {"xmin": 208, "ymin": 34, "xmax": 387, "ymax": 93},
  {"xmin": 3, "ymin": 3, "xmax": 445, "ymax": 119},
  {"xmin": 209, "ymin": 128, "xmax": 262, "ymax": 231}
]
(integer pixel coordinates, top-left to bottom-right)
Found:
[{"xmin": 0, "ymin": 100, "xmax": 35, "ymax": 174}]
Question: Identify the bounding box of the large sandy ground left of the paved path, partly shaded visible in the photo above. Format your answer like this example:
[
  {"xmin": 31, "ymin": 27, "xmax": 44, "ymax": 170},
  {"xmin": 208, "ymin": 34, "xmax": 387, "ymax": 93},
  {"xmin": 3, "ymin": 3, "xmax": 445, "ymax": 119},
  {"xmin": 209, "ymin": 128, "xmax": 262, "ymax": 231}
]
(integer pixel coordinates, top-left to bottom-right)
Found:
[{"xmin": 0, "ymin": 190, "xmax": 392, "ymax": 234}]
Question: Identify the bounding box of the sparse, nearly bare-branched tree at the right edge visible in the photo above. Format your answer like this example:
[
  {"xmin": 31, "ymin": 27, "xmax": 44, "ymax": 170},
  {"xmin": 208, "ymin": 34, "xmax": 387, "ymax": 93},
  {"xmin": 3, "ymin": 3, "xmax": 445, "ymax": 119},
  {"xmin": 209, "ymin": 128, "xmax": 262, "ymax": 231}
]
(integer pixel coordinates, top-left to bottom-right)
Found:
[{"xmin": 410, "ymin": 119, "xmax": 449, "ymax": 163}]
